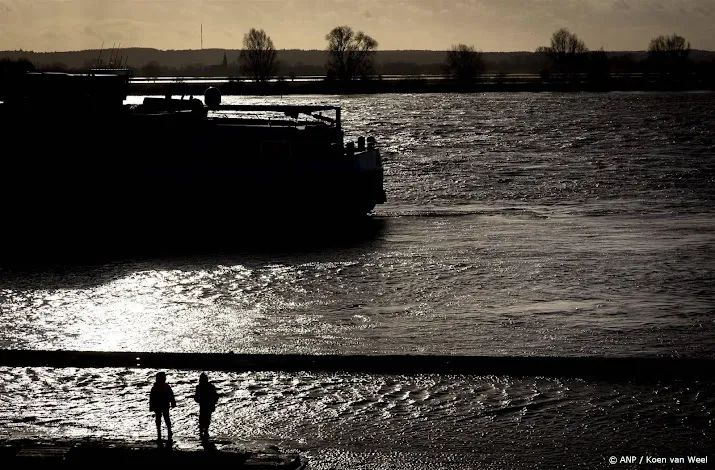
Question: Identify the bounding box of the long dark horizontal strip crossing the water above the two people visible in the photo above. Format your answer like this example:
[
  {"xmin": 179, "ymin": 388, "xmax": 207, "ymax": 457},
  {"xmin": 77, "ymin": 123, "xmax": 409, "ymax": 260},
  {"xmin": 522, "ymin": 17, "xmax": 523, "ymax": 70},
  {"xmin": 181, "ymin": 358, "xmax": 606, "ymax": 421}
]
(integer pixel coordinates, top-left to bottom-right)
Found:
[{"xmin": 0, "ymin": 349, "xmax": 715, "ymax": 380}]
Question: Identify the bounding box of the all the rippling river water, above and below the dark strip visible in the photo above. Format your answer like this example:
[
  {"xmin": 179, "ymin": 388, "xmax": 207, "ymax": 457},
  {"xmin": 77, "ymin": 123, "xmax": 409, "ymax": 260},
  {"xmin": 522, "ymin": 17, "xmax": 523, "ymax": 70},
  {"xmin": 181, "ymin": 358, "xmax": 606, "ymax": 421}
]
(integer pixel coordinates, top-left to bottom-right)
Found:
[{"xmin": 0, "ymin": 93, "xmax": 715, "ymax": 468}]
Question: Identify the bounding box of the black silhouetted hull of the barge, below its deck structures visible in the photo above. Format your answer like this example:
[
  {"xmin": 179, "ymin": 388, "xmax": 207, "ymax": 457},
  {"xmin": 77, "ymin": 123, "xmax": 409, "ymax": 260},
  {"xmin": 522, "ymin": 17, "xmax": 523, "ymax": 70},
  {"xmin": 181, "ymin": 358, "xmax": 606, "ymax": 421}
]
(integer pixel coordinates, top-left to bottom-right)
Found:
[{"xmin": 0, "ymin": 109, "xmax": 385, "ymax": 261}]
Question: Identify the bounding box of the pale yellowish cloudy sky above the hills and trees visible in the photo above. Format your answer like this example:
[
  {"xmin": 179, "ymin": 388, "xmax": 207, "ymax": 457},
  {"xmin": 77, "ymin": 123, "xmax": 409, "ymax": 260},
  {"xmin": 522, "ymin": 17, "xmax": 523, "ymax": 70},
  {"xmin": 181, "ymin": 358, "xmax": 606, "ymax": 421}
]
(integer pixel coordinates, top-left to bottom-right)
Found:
[{"xmin": 0, "ymin": 0, "xmax": 715, "ymax": 52}]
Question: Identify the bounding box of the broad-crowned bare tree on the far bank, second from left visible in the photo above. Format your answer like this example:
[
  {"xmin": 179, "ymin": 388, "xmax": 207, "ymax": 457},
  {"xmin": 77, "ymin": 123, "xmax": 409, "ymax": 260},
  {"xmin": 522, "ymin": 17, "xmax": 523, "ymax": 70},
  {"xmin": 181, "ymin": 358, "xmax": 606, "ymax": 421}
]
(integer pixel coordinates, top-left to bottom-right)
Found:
[{"xmin": 325, "ymin": 26, "xmax": 378, "ymax": 81}]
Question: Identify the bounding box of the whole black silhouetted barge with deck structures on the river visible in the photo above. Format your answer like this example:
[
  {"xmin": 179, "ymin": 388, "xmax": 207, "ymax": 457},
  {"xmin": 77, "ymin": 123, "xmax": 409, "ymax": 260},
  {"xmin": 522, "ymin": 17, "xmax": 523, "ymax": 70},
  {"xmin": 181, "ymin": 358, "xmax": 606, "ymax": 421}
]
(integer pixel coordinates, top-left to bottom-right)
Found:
[{"xmin": 0, "ymin": 70, "xmax": 386, "ymax": 260}]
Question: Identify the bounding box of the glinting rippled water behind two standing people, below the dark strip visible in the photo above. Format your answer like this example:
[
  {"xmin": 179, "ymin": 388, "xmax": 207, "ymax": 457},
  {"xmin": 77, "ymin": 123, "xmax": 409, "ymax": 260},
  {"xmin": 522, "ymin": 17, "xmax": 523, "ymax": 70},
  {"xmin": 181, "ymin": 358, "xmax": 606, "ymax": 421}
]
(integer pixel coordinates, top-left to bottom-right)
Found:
[{"xmin": 0, "ymin": 368, "xmax": 715, "ymax": 468}]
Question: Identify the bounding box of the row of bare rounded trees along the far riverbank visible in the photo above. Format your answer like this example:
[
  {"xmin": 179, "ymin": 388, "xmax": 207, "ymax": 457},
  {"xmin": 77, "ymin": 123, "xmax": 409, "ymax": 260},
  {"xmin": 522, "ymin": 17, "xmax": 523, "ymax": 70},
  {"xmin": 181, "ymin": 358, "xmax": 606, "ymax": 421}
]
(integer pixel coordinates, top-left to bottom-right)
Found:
[{"xmin": 224, "ymin": 26, "xmax": 713, "ymax": 84}]
